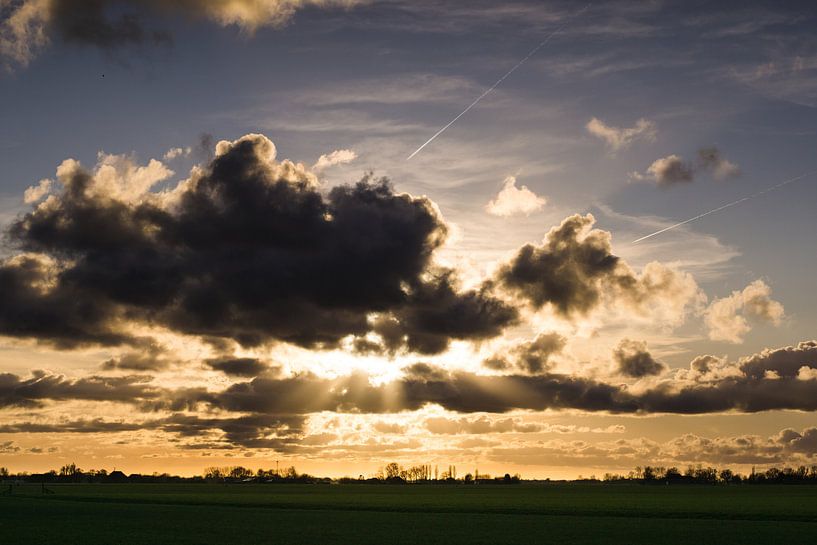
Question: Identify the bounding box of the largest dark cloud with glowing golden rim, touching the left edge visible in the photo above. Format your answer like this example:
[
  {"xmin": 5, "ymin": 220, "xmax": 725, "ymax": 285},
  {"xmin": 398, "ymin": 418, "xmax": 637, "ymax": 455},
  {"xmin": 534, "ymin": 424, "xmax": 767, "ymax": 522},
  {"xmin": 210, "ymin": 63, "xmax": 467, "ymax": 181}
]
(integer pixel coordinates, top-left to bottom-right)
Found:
[{"xmin": 0, "ymin": 135, "xmax": 516, "ymax": 353}]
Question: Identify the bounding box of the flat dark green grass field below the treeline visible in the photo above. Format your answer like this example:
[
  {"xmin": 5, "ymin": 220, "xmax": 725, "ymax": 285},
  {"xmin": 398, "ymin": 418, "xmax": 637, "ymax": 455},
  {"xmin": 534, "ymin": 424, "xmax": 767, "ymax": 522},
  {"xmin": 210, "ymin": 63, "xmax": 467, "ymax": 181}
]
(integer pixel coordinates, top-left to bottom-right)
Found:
[{"xmin": 0, "ymin": 484, "xmax": 817, "ymax": 545}]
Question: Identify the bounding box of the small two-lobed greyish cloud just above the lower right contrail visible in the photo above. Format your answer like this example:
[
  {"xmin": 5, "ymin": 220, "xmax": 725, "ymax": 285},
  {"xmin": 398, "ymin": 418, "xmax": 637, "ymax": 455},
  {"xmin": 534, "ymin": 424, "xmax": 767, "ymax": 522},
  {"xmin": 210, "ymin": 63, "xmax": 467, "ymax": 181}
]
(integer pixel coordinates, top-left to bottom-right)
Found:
[{"xmin": 630, "ymin": 147, "xmax": 741, "ymax": 187}]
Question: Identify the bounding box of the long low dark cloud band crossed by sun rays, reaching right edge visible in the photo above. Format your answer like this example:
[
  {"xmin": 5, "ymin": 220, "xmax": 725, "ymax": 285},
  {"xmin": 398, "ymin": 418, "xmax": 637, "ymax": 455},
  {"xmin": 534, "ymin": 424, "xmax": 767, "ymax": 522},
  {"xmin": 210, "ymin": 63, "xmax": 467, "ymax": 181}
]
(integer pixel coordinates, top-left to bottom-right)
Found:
[{"xmin": 180, "ymin": 341, "xmax": 817, "ymax": 414}]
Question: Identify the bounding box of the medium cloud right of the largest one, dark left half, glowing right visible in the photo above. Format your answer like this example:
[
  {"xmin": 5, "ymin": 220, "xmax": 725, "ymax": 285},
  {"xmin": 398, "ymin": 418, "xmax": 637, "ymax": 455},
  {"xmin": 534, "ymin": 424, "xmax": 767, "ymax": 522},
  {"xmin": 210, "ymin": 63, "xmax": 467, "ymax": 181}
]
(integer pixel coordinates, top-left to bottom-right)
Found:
[{"xmin": 495, "ymin": 214, "xmax": 699, "ymax": 322}]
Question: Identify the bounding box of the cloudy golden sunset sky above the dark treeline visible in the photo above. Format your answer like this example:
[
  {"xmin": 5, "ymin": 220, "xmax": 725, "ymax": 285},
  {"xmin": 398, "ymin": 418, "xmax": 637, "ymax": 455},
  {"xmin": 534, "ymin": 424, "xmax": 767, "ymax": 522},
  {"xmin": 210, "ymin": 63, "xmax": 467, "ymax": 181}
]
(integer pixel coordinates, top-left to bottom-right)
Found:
[{"xmin": 0, "ymin": 0, "xmax": 817, "ymax": 478}]
